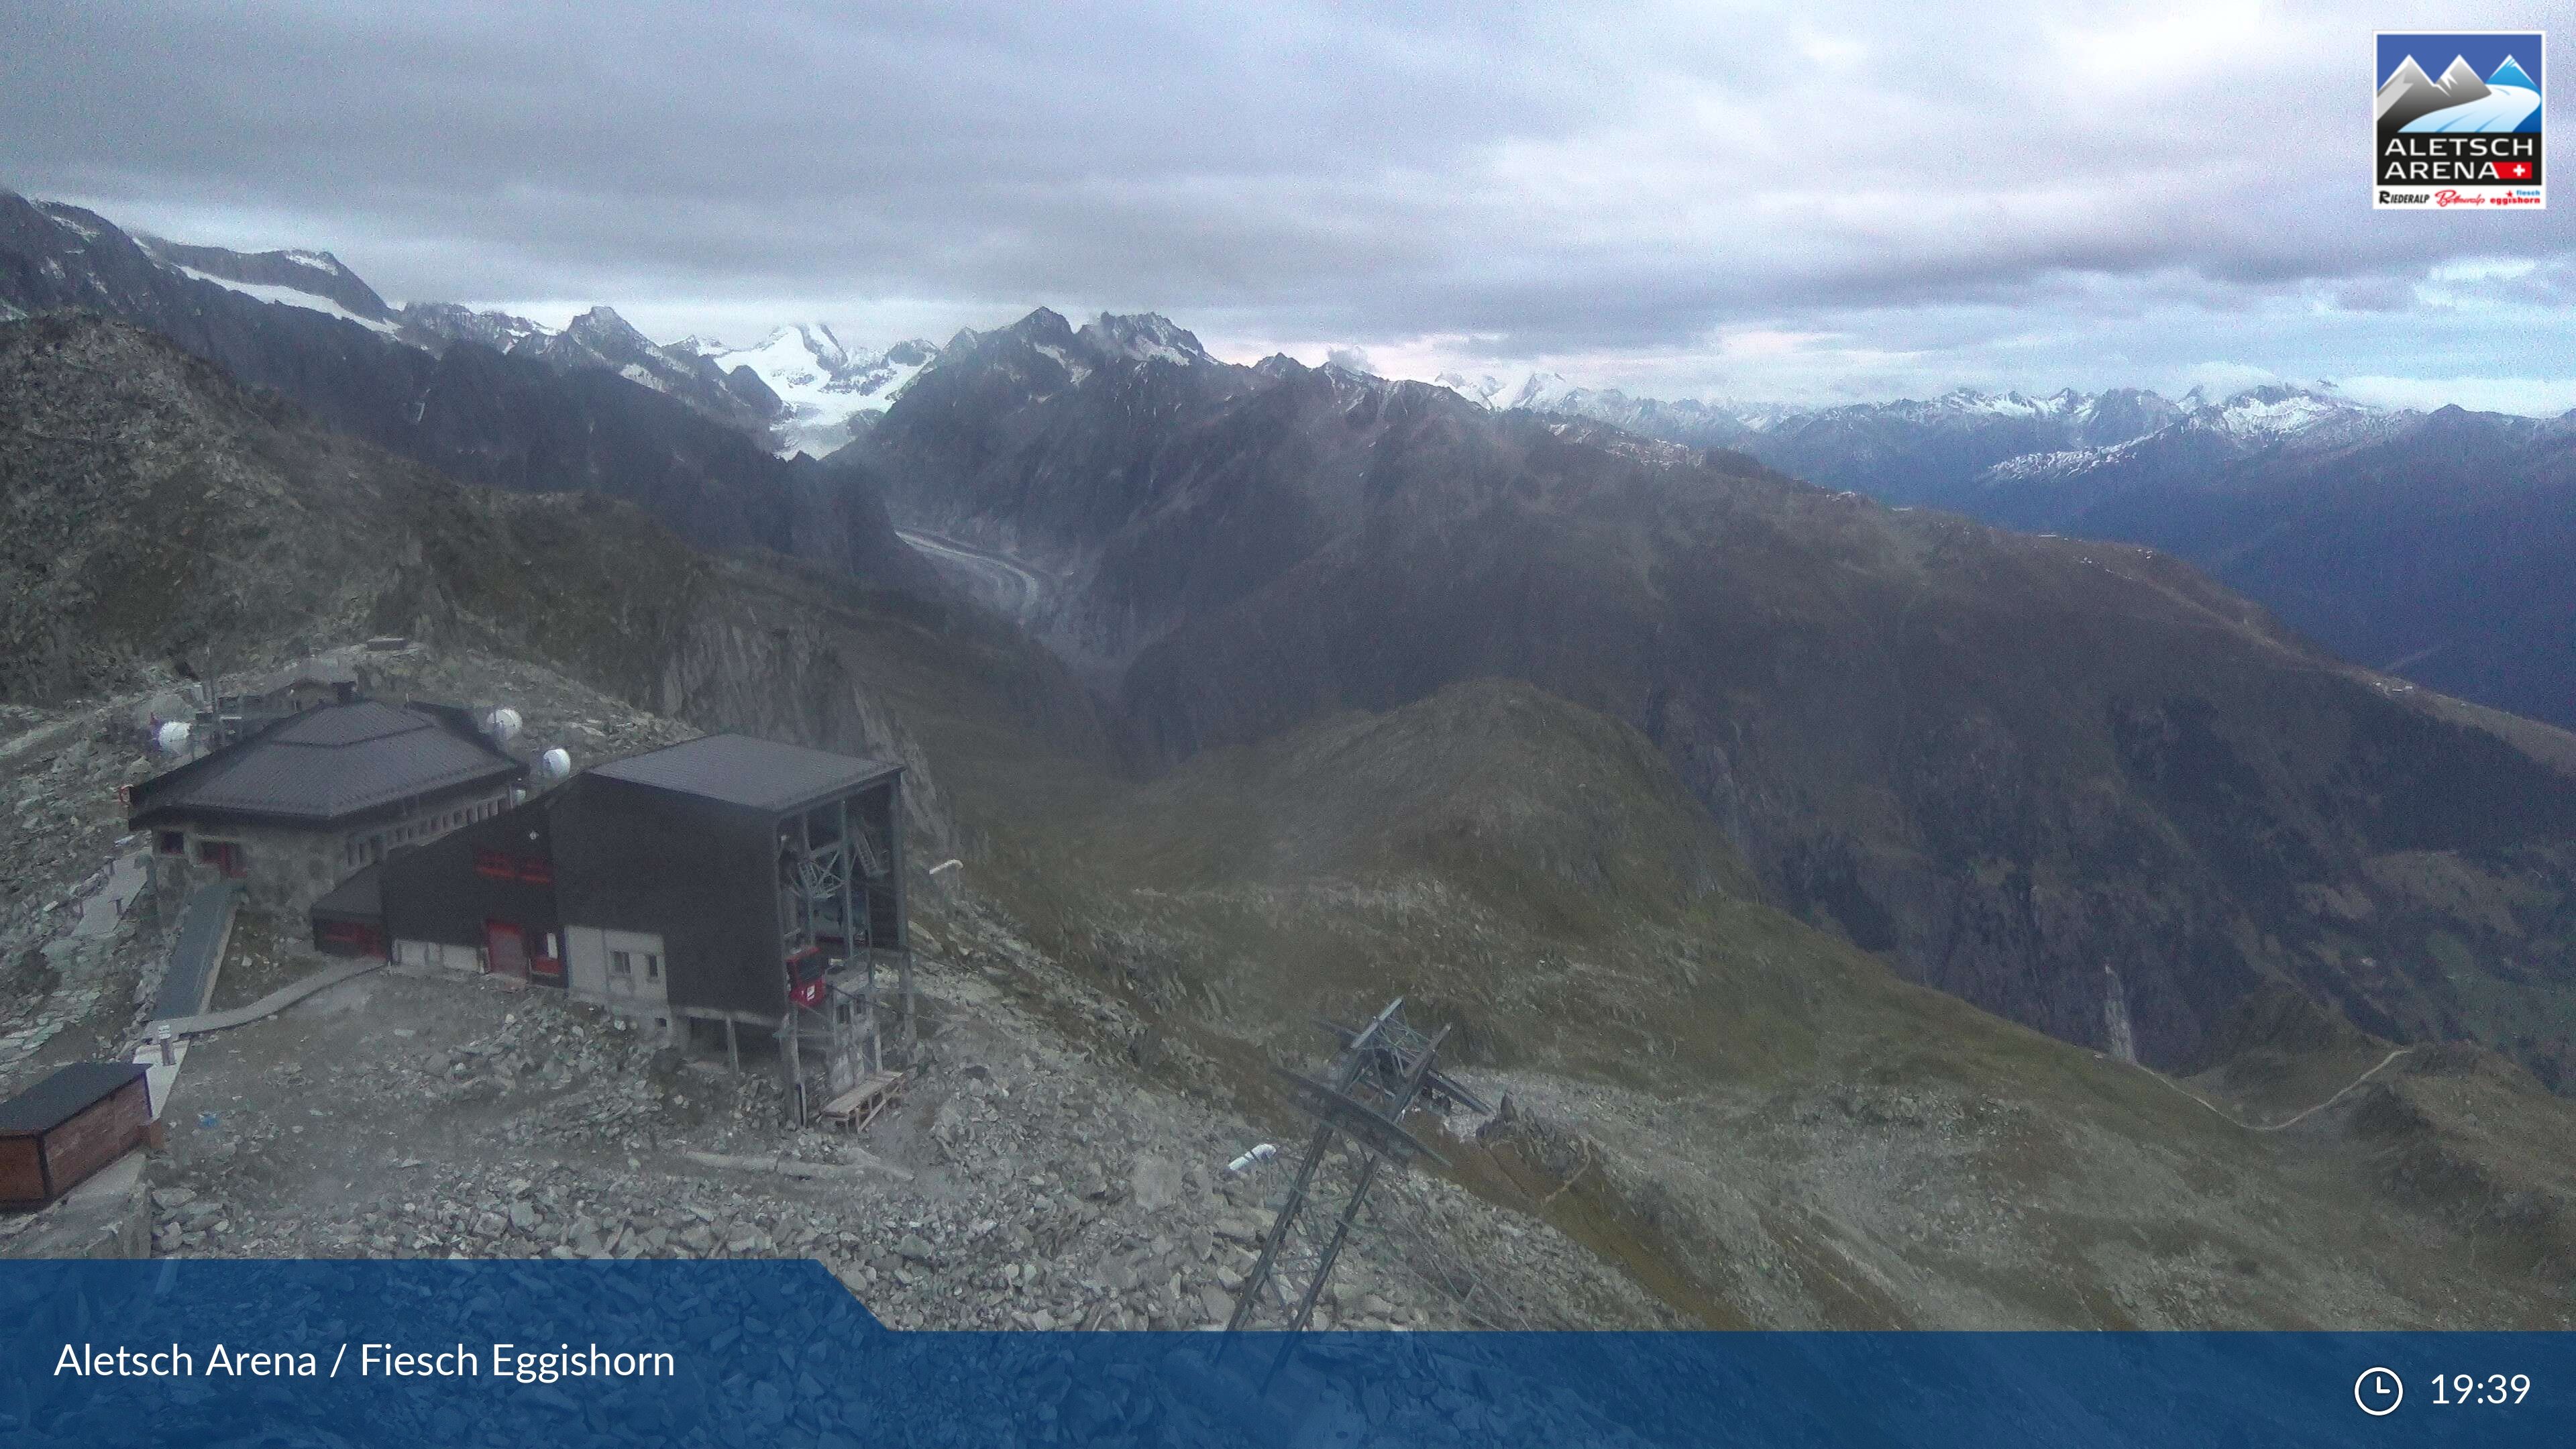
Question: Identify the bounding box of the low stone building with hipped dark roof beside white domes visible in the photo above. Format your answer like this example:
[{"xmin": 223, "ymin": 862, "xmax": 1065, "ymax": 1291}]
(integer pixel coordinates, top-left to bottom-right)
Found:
[{"xmin": 126, "ymin": 699, "xmax": 528, "ymax": 910}]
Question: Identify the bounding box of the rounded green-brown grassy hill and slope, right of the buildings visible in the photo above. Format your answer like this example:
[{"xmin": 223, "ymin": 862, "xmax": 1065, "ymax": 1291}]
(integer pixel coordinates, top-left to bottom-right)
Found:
[{"xmin": 1010, "ymin": 678, "xmax": 2576, "ymax": 1328}]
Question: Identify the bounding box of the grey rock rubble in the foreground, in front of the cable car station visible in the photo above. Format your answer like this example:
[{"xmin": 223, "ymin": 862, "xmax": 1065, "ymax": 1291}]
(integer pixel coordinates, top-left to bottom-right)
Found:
[{"xmin": 154, "ymin": 902, "xmax": 1659, "ymax": 1328}]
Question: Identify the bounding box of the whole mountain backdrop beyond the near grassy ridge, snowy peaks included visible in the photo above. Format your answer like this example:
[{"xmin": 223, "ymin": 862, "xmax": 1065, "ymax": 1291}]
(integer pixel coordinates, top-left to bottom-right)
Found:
[{"xmin": 15, "ymin": 196, "xmax": 2576, "ymax": 1103}]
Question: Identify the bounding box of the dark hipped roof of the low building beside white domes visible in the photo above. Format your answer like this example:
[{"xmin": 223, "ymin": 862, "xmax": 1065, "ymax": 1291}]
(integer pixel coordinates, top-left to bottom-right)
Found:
[{"xmin": 131, "ymin": 699, "xmax": 525, "ymax": 825}]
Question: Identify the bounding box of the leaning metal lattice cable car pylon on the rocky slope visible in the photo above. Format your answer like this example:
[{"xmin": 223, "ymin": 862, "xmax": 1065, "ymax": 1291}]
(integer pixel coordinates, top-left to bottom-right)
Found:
[{"xmin": 1218, "ymin": 996, "xmax": 1481, "ymax": 1382}]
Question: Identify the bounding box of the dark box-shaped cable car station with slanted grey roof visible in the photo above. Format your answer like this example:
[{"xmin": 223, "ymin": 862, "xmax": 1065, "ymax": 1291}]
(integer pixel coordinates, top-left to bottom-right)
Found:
[{"xmin": 335, "ymin": 735, "xmax": 907, "ymax": 1034}]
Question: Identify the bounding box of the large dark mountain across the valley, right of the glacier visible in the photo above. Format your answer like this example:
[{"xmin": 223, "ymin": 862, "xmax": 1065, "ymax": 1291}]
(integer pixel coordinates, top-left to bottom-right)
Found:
[{"xmin": 855, "ymin": 312, "xmax": 2576, "ymax": 1080}]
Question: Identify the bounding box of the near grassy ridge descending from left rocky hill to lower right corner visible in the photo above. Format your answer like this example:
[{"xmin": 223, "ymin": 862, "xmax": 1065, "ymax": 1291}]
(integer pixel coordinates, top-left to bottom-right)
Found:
[{"xmin": 20, "ymin": 320, "xmax": 2576, "ymax": 1326}]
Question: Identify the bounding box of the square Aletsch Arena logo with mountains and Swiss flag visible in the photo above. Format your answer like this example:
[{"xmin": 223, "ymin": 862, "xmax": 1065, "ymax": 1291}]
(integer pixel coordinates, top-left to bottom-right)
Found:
[{"xmin": 2370, "ymin": 31, "xmax": 2548, "ymax": 209}]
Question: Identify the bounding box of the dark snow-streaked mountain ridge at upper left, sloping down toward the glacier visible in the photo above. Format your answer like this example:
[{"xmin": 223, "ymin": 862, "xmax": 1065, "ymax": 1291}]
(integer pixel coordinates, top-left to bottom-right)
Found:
[{"xmin": 0, "ymin": 193, "xmax": 943, "ymax": 593}]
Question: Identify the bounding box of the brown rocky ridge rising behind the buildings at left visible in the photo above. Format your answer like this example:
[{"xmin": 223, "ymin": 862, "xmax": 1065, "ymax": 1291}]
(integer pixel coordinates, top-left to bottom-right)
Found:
[{"xmin": 0, "ymin": 312, "xmax": 1105, "ymax": 841}]
